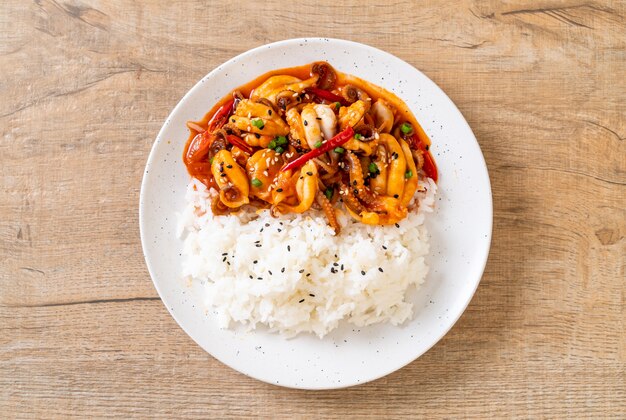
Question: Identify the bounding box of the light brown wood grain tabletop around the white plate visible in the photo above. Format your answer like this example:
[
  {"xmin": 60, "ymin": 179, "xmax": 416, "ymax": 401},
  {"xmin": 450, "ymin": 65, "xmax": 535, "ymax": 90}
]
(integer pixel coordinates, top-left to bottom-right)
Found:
[{"xmin": 0, "ymin": 0, "xmax": 626, "ymax": 418}]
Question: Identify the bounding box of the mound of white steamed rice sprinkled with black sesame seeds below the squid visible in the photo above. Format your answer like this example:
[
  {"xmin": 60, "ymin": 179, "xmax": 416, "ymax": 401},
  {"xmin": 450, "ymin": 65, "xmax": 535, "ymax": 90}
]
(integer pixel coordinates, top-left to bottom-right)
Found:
[{"xmin": 179, "ymin": 179, "xmax": 436, "ymax": 337}]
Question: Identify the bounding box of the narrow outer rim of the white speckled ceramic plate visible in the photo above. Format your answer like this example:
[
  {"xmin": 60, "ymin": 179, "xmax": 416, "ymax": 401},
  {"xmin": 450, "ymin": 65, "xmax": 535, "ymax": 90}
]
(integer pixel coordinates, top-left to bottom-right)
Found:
[{"xmin": 139, "ymin": 38, "xmax": 493, "ymax": 390}]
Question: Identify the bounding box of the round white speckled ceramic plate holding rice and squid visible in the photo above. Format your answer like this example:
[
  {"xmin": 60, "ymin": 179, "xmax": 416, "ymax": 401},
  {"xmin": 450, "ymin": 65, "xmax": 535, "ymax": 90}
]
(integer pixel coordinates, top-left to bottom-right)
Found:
[{"xmin": 139, "ymin": 38, "xmax": 492, "ymax": 389}]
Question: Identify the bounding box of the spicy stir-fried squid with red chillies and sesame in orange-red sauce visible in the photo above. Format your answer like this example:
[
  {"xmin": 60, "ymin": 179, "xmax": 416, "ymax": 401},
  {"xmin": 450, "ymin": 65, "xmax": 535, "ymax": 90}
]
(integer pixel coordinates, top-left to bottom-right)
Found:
[{"xmin": 183, "ymin": 62, "xmax": 437, "ymax": 233}]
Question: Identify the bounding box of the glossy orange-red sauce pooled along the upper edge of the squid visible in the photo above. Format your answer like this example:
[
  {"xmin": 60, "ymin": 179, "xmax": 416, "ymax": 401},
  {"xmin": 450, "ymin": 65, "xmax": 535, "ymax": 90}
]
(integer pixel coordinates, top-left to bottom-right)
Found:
[{"xmin": 183, "ymin": 64, "xmax": 438, "ymax": 186}]
